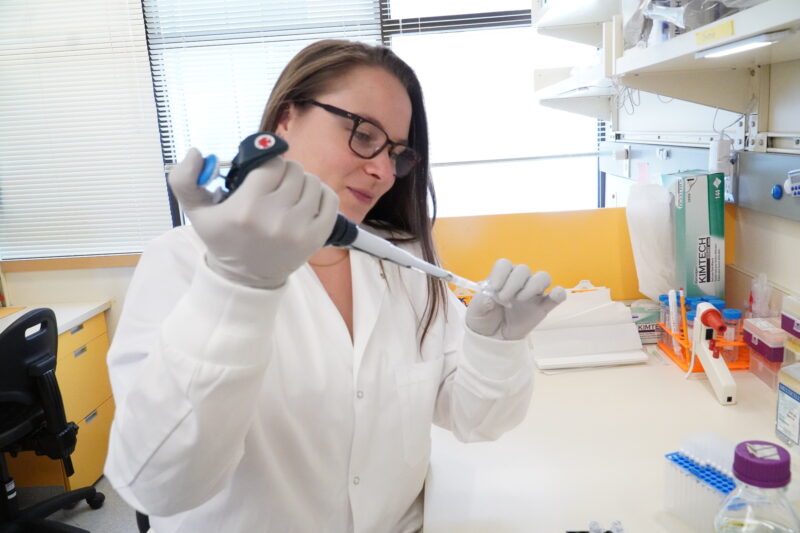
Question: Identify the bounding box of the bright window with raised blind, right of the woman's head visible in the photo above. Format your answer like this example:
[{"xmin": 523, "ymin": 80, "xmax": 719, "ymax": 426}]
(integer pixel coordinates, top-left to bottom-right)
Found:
[{"xmin": 387, "ymin": 0, "xmax": 598, "ymax": 217}]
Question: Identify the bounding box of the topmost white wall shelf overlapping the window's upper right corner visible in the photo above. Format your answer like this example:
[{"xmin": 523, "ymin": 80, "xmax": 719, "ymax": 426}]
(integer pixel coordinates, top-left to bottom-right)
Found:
[{"xmin": 533, "ymin": 0, "xmax": 620, "ymax": 48}]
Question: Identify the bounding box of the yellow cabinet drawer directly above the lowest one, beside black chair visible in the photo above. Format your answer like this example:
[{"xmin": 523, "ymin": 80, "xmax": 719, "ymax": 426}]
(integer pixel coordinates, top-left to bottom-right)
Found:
[{"xmin": 56, "ymin": 333, "xmax": 111, "ymax": 422}]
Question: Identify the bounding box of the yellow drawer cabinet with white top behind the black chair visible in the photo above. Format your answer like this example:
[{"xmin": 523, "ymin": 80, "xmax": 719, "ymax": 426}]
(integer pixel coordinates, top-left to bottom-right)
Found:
[{"xmin": 0, "ymin": 302, "xmax": 114, "ymax": 490}]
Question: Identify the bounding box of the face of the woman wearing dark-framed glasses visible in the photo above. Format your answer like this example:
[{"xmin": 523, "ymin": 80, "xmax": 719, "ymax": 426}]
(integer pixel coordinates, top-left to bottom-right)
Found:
[{"xmin": 275, "ymin": 67, "xmax": 411, "ymax": 223}]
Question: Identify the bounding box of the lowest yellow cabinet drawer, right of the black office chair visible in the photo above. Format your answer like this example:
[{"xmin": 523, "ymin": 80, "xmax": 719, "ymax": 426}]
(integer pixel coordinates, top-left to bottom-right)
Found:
[{"xmin": 67, "ymin": 398, "xmax": 114, "ymax": 490}]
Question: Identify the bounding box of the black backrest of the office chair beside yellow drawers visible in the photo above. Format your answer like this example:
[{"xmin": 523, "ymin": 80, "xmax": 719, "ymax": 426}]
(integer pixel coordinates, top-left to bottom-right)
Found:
[{"xmin": 0, "ymin": 308, "xmax": 78, "ymax": 475}]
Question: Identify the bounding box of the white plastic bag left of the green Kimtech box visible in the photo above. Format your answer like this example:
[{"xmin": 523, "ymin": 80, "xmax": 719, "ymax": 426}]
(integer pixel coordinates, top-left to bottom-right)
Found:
[{"xmin": 626, "ymin": 184, "xmax": 675, "ymax": 301}]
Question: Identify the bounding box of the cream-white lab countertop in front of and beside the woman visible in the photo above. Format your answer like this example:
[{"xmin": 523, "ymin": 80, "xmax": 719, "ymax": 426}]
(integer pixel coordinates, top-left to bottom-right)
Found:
[{"xmin": 425, "ymin": 350, "xmax": 788, "ymax": 533}]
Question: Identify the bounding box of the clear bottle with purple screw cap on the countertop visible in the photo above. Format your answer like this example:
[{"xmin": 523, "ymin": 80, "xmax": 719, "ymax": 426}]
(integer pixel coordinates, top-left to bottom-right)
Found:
[{"xmin": 714, "ymin": 440, "xmax": 800, "ymax": 533}]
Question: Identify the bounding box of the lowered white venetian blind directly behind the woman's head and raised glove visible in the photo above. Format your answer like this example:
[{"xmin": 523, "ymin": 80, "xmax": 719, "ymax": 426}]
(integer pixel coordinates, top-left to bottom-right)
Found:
[{"xmin": 143, "ymin": 0, "xmax": 381, "ymax": 165}]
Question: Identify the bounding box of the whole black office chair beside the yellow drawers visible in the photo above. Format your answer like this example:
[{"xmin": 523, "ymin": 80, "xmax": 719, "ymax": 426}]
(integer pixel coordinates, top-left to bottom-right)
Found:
[{"xmin": 0, "ymin": 308, "xmax": 105, "ymax": 533}]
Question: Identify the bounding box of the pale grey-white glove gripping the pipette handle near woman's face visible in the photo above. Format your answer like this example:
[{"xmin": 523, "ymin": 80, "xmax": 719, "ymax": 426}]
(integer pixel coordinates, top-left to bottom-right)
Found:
[{"xmin": 169, "ymin": 148, "xmax": 339, "ymax": 289}]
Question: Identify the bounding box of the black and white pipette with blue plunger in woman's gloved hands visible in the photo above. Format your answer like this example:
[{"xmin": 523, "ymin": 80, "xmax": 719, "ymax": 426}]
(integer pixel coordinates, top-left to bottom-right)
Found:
[{"xmin": 197, "ymin": 132, "xmax": 496, "ymax": 305}]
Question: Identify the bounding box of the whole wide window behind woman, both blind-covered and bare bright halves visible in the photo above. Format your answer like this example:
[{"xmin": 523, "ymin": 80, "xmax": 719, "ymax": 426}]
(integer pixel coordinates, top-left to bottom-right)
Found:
[{"xmin": 144, "ymin": 0, "xmax": 597, "ymax": 220}]
